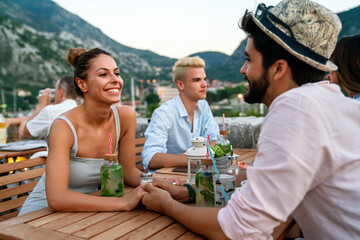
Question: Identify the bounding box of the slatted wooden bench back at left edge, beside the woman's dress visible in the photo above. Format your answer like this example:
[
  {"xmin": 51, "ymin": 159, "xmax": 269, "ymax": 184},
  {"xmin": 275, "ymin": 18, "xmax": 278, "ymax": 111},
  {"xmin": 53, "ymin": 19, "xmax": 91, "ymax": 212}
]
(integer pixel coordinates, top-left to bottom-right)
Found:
[{"xmin": 0, "ymin": 157, "xmax": 46, "ymax": 221}]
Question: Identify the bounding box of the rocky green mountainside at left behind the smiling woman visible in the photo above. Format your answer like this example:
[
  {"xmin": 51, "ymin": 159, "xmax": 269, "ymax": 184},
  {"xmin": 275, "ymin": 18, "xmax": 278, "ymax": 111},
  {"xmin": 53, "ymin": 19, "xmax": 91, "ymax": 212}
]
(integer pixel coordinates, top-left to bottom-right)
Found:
[{"xmin": 0, "ymin": 0, "xmax": 175, "ymax": 107}]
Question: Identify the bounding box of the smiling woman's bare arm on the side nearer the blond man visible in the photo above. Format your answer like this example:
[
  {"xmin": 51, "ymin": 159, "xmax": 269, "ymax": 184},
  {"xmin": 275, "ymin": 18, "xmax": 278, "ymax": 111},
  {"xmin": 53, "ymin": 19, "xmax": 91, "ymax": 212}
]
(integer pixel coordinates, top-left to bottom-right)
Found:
[{"xmin": 117, "ymin": 106, "xmax": 141, "ymax": 186}]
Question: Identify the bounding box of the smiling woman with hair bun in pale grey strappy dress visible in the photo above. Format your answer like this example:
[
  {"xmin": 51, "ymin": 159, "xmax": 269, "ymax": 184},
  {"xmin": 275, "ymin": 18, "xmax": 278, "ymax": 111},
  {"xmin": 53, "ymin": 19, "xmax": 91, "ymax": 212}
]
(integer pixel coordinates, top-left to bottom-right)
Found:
[{"xmin": 20, "ymin": 48, "xmax": 145, "ymax": 214}]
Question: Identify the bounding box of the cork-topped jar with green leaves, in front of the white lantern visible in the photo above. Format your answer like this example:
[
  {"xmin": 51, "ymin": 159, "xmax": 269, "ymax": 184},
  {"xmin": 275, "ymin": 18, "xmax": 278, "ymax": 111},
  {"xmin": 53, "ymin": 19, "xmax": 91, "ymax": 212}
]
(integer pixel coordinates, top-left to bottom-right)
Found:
[{"xmin": 195, "ymin": 158, "xmax": 214, "ymax": 207}]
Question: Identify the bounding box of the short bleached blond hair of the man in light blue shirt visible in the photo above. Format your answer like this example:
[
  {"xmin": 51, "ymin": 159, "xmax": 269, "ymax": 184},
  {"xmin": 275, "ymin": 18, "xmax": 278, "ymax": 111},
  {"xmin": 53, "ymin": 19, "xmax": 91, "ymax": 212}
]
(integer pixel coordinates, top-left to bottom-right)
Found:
[{"xmin": 173, "ymin": 56, "xmax": 205, "ymax": 83}]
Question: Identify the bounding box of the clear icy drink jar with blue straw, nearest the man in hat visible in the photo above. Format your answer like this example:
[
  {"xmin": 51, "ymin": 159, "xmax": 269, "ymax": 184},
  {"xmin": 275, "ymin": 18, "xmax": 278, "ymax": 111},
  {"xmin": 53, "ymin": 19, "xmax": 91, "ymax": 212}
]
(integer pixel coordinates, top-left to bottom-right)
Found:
[{"xmin": 213, "ymin": 156, "xmax": 236, "ymax": 207}]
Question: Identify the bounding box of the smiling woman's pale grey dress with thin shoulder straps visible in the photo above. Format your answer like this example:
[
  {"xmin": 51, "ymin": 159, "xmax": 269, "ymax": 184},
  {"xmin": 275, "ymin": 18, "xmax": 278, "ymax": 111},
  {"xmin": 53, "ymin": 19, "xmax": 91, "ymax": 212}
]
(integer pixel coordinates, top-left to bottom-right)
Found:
[{"xmin": 19, "ymin": 106, "xmax": 121, "ymax": 215}]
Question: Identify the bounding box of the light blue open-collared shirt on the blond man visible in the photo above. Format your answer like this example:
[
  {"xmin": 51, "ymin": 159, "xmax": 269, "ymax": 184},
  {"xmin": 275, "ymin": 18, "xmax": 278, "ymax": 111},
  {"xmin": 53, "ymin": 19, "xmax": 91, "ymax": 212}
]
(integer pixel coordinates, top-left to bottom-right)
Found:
[{"xmin": 142, "ymin": 95, "xmax": 219, "ymax": 168}]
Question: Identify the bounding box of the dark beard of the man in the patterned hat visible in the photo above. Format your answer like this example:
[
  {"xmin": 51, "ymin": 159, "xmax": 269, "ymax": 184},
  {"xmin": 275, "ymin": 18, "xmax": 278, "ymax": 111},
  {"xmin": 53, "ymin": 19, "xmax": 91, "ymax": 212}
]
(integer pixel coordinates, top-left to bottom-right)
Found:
[{"xmin": 244, "ymin": 71, "xmax": 269, "ymax": 103}]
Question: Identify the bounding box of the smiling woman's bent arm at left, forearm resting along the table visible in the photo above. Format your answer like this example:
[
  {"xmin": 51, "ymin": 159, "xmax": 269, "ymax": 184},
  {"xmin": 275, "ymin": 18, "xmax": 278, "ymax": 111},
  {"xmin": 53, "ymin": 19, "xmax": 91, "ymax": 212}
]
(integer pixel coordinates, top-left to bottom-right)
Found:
[{"xmin": 45, "ymin": 120, "xmax": 144, "ymax": 211}]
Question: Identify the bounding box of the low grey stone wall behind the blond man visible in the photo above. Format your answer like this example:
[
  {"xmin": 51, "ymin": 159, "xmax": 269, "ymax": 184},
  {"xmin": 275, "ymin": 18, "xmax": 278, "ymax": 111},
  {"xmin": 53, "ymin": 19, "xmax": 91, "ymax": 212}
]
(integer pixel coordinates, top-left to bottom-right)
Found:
[{"xmin": 136, "ymin": 117, "xmax": 263, "ymax": 148}]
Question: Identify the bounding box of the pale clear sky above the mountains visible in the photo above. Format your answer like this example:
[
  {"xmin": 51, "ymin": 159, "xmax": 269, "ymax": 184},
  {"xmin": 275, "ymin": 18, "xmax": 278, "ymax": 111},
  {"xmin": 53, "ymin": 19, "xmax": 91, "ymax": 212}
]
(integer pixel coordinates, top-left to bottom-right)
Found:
[{"xmin": 53, "ymin": 0, "xmax": 360, "ymax": 58}]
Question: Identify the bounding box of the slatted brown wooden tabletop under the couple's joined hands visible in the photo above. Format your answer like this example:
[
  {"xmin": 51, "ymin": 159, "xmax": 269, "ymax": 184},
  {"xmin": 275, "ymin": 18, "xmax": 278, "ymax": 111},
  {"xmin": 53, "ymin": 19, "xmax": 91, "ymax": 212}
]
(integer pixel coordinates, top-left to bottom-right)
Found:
[{"xmin": 0, "ymin": 150, "xmax": 292, "ymax": 240}]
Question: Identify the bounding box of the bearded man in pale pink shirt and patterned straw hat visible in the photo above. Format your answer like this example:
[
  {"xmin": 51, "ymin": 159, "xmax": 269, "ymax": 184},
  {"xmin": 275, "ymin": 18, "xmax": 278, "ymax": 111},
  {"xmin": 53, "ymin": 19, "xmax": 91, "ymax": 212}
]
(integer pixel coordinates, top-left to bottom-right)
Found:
[{"xmin": 142, "ymin": 0, "xmax": 360, "ymax": 239}]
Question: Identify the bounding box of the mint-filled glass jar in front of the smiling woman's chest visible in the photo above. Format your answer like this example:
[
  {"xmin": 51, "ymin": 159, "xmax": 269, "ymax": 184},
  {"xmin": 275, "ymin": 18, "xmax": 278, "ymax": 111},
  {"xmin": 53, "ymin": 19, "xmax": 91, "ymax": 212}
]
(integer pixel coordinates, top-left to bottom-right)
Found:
[{"xmin": 100, "ymin": 154, "xmax": 124, "ymax": 197}]
